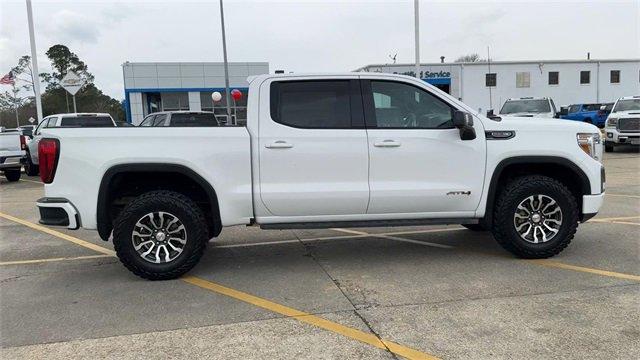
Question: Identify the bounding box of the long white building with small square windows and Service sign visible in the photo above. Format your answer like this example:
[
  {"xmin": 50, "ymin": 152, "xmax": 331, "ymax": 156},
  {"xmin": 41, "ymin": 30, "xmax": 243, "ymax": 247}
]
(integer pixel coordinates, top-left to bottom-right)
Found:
[{"xmin": 356, "ymin": 59, "xmax": 640, "ymax": 113}]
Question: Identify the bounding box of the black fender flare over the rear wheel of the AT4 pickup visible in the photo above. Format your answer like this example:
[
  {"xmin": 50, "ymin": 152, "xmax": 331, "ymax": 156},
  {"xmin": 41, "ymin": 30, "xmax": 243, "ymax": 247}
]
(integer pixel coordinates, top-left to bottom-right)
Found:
[{"xmin": 96, "ymin": 163, "xmax": 222, "ymax": 241}]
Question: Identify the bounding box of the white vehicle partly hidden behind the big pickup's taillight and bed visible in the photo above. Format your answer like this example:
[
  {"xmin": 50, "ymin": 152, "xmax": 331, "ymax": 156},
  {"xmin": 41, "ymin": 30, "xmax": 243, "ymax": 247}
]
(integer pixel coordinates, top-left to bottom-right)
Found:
[{"xmin": 24, "ymin": 113, "xmax": 116, "ymax": 176}]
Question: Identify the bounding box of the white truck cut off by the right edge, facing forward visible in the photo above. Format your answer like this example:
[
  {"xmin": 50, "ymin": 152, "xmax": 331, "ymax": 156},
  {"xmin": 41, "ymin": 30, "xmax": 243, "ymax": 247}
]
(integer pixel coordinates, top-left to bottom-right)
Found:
[{"xmin": 604, "ymin": 96, "xmax": 640, "ymax": 152}]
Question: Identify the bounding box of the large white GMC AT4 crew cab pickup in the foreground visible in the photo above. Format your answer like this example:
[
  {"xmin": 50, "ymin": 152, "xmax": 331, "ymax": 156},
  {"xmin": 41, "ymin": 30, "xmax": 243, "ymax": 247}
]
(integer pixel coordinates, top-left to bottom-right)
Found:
[{"xmin": 37, "ymin": 73, "xmax": 605, "ymax": 279}]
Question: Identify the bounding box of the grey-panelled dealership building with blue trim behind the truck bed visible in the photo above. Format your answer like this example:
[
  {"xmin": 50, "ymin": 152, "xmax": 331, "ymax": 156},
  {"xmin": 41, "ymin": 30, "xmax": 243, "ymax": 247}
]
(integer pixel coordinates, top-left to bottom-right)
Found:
[{"xmin": 122, "ymin": 62, "xmax": 269, "ymax": 125}]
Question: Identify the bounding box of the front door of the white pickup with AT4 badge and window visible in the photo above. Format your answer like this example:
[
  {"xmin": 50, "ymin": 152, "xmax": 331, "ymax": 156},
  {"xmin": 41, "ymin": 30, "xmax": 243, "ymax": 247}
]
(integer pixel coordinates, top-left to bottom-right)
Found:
[{"xmin": 362, "ymin": 76, "xmax": 486, "ymax": 218}]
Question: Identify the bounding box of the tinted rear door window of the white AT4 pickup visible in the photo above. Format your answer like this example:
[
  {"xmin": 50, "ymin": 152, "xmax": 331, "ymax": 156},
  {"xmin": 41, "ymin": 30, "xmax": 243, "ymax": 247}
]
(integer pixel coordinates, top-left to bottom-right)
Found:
[{"xmin": 271, "ymin": 80, "xmax": 351, "ymax": 129}]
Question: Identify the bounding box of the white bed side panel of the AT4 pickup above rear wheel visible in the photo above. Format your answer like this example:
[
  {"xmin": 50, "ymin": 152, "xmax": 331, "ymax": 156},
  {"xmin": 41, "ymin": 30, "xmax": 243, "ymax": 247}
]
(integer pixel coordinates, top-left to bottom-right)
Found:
[{"xmin": 44, "ymin": 127, "xmax": 253, "ymax": 229}]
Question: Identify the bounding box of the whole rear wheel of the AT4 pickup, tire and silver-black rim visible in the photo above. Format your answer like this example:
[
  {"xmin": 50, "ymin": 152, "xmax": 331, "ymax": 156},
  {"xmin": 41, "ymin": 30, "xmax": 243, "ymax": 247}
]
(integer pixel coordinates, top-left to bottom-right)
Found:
[{"xmin": 113, "ymin": 190, "xmax": 208, "ymax": 280}]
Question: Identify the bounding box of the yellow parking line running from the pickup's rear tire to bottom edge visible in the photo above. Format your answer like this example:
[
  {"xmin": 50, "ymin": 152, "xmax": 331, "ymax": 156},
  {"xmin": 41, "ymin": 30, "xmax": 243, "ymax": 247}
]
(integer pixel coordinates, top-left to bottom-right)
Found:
[{"xmin": 182, "ymin": 276, "xmax": 437, "ymax": 359}]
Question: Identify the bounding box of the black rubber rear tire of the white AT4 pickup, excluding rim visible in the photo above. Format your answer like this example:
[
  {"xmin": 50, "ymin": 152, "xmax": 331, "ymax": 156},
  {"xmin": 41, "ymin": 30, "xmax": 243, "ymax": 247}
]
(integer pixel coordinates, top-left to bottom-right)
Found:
[{"xmin": 113, "ymin": 190, "xmax": 208, "ymax": 280}]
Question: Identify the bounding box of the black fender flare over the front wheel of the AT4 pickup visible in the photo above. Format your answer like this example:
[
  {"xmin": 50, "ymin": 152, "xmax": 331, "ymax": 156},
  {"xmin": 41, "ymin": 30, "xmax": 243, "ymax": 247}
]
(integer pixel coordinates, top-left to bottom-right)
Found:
[{"xmin": 484, "ymin": 156, "xmax": 591, "ymax": 224}]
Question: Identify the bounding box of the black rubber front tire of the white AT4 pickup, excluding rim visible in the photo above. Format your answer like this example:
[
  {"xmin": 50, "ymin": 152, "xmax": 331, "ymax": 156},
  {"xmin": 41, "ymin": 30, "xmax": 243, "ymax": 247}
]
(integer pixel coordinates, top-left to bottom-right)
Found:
[{"xmin": 492, "ymin": 175, "xmax": 578, "ymax": 259}]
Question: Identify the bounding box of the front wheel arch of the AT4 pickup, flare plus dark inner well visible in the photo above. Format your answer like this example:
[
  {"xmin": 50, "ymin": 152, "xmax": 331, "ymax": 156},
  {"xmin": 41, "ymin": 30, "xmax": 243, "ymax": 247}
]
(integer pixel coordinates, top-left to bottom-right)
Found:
[{"xmin": 484, "ymin": 156, "xmax": 591, "ymax": 225}]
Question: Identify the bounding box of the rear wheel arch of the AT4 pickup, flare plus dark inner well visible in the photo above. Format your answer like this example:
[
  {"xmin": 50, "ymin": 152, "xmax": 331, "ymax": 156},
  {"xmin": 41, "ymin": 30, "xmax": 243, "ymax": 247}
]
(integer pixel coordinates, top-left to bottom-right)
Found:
[{"xmin": 96, "ymin": 163, "xmax": 222, "ymax": 241}]
